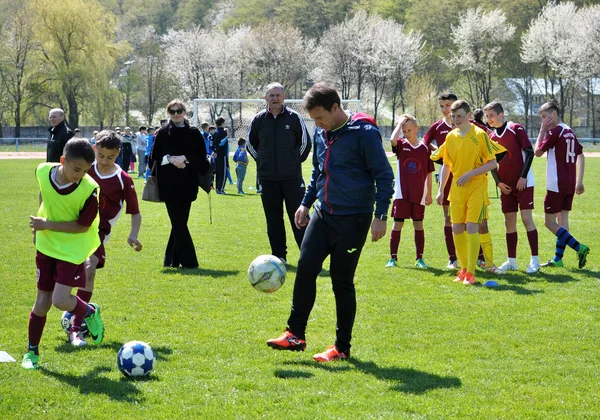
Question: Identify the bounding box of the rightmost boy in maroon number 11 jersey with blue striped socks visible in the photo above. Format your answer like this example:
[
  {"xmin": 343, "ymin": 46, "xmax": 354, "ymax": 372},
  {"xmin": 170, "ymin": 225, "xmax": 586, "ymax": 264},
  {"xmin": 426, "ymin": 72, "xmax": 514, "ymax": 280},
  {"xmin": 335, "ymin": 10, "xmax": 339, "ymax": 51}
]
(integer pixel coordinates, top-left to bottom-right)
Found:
[{"xmin": 535, "ymin": 102, "xmax": 590, "ymax": 268}]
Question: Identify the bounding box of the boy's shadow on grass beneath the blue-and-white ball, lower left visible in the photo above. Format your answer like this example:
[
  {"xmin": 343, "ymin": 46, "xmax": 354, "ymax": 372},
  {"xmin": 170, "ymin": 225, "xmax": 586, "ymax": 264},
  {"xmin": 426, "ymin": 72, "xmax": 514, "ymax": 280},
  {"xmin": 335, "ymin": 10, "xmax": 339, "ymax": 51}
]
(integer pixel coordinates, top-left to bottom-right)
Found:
[{"xmin": 39, "ymin": 367, "xmax": 158, "ymax": 404}]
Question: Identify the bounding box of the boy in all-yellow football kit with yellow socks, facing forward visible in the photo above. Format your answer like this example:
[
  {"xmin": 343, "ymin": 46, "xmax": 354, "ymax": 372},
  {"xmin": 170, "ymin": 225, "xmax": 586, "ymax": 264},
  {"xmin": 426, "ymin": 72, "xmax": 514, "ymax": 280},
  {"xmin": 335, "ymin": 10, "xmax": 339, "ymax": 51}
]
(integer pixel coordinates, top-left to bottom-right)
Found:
[{"xmin": 432, "ymin": 100, "xmax": 498, "ymax": 284}]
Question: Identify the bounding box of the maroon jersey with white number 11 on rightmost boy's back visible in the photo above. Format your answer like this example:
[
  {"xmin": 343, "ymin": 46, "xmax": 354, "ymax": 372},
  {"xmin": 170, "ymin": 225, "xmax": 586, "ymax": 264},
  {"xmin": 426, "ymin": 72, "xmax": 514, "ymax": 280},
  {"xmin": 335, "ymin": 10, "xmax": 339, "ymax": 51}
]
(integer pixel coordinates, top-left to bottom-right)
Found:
[{"xmin": 539, "ymin": 123, "xmax": 583, "ymax": 194}]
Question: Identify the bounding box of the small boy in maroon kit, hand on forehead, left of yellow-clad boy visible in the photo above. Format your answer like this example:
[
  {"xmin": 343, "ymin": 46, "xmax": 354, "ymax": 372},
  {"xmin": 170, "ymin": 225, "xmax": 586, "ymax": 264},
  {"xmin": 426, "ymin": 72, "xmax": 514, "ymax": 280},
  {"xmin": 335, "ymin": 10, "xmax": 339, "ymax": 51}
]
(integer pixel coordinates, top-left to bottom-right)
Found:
[{"xmin": 386, "ymin": 114, "xmax": 434, "ymax": 268}]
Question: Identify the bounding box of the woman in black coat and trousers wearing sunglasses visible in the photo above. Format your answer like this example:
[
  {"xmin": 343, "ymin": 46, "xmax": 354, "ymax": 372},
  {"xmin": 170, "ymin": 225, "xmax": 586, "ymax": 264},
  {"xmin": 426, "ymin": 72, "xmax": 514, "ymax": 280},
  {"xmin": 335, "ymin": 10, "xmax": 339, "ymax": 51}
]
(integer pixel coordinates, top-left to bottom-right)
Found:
[{"xmin": 149, "ymin": 99, "xmax": 209, "ymax": 268}]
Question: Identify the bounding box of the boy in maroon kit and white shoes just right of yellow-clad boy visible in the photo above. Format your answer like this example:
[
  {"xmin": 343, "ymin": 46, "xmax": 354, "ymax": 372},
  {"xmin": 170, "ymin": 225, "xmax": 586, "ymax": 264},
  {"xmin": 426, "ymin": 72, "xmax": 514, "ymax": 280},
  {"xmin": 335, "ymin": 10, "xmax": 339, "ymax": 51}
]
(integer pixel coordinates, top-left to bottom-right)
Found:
[{"xmin": 484, "ymin": 102, "xmax": 540, "ymax": 274}]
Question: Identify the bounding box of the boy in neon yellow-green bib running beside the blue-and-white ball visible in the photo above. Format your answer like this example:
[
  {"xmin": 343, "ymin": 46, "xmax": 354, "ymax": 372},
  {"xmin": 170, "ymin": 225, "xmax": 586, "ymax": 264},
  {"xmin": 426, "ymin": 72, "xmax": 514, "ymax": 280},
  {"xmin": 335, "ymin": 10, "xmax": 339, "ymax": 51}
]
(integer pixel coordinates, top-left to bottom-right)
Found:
[{"xmin": 21, "ymin": 139, "xmax": 104, "ymax": 369}]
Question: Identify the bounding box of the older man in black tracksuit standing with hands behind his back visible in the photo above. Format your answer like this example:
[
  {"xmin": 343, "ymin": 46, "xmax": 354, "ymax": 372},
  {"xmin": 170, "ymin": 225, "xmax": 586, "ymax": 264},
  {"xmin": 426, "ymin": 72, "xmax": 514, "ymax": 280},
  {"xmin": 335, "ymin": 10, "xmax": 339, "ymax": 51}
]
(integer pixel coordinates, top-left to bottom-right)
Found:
[{"xmin": 246, "ymin": 83, "xmax": 311, "ymax": 263}]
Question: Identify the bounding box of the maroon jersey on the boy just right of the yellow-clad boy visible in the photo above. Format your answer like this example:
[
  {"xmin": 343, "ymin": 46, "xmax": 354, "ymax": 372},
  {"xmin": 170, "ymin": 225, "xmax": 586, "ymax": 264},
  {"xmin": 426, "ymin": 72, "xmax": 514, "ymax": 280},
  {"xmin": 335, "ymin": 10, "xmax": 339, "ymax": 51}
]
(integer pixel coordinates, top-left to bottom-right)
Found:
[{"xmin": 490, "ymin": 121, "xmax": 535, "ymax": 191}]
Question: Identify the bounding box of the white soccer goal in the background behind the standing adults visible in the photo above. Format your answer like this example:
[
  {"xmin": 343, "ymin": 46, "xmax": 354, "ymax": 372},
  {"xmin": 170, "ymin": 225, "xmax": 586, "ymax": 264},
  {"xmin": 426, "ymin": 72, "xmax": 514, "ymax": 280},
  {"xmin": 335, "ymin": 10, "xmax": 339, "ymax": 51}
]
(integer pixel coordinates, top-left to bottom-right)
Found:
[{"xmin": 192, "ymin": 98, "xmax": 360, "ymax": 138}]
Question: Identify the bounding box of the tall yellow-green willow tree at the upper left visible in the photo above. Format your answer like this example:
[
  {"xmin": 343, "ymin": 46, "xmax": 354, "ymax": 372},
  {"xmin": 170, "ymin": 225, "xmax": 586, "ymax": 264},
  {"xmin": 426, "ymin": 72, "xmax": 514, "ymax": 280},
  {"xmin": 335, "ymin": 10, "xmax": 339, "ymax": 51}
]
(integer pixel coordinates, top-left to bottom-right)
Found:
[{"xmin": 33, "ymin": 0, "xmax": 127, "ymax": 127}]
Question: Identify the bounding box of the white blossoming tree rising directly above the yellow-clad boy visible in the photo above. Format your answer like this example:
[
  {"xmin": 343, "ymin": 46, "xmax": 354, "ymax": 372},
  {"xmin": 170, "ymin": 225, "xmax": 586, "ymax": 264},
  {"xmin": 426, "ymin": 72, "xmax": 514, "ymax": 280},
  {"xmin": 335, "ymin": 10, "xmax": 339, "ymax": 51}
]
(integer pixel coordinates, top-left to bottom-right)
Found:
[{"xmin": 449, "ymin": 7, "xmax": 516, "ymax": 104}]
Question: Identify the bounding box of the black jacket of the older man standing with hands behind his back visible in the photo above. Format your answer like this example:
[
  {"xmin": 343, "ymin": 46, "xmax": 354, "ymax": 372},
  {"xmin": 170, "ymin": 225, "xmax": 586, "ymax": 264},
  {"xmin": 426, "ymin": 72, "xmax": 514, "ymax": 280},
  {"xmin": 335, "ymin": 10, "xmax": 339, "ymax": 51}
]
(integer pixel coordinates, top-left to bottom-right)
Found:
[{"xmin": 246, "ymin": 106, "xmax": 312, "ymax": 181}]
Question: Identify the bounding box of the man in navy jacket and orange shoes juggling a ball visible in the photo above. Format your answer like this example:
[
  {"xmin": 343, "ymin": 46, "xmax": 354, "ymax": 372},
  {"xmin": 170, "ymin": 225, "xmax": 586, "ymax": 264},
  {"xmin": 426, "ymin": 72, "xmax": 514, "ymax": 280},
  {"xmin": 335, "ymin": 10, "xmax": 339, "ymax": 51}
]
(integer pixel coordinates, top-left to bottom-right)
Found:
[{"xmin": 267, "ymin": 83, "xmax": 394, "ymax": 362}]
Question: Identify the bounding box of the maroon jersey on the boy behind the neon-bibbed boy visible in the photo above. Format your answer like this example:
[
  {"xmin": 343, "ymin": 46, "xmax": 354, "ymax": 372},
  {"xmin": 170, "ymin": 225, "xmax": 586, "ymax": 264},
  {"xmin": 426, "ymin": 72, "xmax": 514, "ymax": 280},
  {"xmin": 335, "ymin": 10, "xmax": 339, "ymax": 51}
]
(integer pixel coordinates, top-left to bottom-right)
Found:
[{"xmin": 88, "ymin": 162, "xmax": 140, "ymax": 243}]
